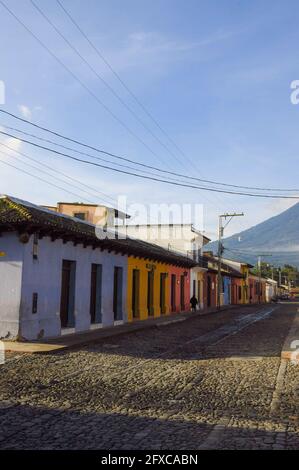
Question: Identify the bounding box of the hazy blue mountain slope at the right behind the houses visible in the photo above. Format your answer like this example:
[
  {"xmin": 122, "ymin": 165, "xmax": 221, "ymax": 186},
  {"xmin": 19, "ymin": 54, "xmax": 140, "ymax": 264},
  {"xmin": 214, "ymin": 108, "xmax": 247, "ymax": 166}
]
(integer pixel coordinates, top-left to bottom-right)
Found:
[{"xmin": 204, "ymin": 203, "xmax": 299, "ymax": 267}]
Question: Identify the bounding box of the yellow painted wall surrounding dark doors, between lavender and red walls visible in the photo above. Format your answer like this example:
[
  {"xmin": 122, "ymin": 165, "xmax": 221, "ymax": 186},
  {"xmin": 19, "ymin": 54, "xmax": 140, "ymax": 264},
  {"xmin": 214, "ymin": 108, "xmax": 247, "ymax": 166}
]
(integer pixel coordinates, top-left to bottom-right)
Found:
[{"xmin": 127, "ymin": 256, "xmax": 170, "ymax": 322}]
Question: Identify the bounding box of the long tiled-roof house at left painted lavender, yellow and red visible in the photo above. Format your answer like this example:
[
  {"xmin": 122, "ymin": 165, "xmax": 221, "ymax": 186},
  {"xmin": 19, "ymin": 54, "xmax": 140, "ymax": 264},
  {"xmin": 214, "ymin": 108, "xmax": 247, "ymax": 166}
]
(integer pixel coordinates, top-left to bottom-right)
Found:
[{"xmin": 0, "ymin": 196, "xmax": 195, "ymax": 340}]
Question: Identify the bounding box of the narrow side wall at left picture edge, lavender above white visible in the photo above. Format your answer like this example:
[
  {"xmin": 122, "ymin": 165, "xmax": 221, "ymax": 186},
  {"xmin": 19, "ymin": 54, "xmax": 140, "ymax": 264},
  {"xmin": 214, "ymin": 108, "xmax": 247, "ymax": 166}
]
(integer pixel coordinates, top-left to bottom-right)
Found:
[{"xmin": 0, "ymin": 233, "xmax": 24, "ymax": 339}]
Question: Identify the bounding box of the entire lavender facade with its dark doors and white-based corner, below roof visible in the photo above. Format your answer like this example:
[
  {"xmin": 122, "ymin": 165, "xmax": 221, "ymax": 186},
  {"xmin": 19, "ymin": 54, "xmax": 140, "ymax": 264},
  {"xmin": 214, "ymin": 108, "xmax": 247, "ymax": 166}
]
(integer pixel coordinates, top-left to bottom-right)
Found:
[{"xmin": 0, "ymin": 232, "xmax": 127, "ymax": 339}]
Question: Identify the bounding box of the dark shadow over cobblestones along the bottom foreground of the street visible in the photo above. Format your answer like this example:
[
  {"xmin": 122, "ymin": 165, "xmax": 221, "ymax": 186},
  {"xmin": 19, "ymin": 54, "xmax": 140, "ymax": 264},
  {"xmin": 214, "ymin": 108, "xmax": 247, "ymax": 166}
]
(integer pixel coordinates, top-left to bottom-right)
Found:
[{"xmin": 0, "ymin": 405, "xmax": 299, "ymax": 450}]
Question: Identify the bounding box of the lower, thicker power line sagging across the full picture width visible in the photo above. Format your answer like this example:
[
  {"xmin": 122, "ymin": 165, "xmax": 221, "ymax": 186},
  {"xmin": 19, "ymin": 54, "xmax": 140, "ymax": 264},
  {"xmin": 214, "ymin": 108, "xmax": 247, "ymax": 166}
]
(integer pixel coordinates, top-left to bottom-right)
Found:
[{"xmin": 0, "ymin": 131, "xmax": 299, "ymax": 199}]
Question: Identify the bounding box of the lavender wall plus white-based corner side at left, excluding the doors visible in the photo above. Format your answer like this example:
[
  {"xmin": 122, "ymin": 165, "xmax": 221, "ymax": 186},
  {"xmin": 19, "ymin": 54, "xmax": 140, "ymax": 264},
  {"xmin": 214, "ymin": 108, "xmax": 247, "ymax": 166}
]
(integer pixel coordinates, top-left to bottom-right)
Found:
[{"xmin": 0, "ymin": 234, "xmax": 127, "ymax": 340}]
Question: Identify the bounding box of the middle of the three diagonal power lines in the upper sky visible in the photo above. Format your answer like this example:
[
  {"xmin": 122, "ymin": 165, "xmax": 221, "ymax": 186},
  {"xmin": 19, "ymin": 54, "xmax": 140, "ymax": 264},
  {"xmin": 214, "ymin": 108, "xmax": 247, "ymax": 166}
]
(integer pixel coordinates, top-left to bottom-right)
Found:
[{"xmin": 30, "ymin": 0, "xmax": 186, "ymax": 171}]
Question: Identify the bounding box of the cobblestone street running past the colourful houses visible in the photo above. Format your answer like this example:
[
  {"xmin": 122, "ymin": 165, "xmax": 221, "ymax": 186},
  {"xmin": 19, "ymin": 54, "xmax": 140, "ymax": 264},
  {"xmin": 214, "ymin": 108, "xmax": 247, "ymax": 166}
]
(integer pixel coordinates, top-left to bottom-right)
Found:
[{"xmin": 0, "ymin": 304, "xmax": 299, "ymax": 450}]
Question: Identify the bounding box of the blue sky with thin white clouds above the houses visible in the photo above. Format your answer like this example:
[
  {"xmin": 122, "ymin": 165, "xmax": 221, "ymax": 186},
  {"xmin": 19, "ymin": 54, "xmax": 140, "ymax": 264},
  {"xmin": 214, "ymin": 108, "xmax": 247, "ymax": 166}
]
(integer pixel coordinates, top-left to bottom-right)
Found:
[{"xmin": 0, "ymin": 0, "xmax": 299, "ymax": 238}]
